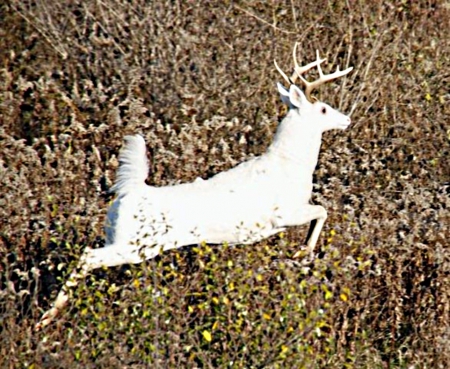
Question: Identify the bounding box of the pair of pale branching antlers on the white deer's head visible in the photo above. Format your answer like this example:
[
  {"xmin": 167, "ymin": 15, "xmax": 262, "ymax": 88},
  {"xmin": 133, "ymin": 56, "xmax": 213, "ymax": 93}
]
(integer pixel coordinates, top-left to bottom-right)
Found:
[{"xmin": 274, "ymin": 42, "xmax": 353, "ymax": 101}]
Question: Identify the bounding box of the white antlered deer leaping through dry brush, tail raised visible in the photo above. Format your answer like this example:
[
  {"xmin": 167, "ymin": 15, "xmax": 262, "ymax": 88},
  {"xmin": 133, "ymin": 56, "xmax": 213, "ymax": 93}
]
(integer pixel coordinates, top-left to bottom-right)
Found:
[{"xmin": 36, "ymin": 43, "xmax": 352, "ymax": 329}]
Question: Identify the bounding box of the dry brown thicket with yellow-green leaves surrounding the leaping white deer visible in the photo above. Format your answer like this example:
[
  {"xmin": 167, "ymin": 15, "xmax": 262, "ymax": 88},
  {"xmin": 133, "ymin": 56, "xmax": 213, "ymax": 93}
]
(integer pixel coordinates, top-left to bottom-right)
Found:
[{"xmin": 0, "ymin": 0, "xmax": 450, "ymax": 368}]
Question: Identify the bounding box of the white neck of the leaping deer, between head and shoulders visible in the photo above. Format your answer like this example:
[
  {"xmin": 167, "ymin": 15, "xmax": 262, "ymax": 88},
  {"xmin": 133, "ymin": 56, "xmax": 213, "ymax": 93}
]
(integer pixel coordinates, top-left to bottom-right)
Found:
[{"xmin": 269, "ymin": 110, "xmax": 322, "ymax": 176}]
